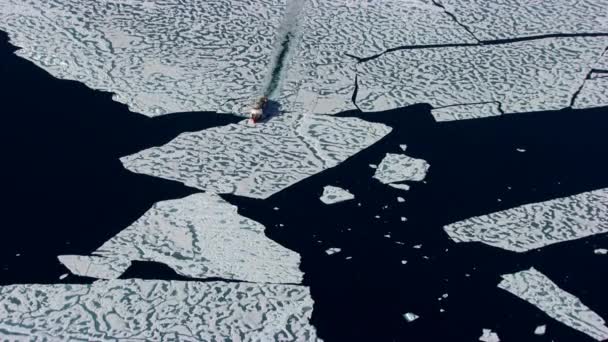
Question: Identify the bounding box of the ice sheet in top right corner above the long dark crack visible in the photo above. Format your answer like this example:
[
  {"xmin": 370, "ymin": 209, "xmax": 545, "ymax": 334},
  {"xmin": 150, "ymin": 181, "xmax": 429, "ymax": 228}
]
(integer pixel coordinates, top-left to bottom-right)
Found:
[{"xmin": 437, "ymin": 0, "xmax": 608, "ymax": 40}]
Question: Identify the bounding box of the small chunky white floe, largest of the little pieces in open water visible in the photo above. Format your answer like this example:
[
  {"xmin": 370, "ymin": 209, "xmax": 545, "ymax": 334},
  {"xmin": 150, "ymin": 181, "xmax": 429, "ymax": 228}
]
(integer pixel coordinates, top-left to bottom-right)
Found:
[{"xmin": 374, "ymin": 153, "xmax": 430, "ymax": 184}]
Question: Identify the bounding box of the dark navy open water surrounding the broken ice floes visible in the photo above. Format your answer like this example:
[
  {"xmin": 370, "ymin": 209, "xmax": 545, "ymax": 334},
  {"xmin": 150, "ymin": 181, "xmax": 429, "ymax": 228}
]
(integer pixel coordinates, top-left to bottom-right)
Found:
[{"xmin": 0, "ymin": 33, "xmax": 608, "ymax": 342}]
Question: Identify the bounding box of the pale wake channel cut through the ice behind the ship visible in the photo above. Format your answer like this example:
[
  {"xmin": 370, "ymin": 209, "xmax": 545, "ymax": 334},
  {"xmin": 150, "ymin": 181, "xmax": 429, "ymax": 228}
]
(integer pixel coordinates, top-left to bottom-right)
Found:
[{"xmin": 262, "ymin": 0, "xmax": 305, "ymax": 97}]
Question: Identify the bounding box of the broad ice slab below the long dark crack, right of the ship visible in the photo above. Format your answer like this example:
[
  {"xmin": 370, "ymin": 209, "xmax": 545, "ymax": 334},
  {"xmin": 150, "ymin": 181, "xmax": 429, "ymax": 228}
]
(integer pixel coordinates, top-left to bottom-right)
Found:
[{"xmin": 357, "ymin": 37, "xmax": 608, "ymax": 118}]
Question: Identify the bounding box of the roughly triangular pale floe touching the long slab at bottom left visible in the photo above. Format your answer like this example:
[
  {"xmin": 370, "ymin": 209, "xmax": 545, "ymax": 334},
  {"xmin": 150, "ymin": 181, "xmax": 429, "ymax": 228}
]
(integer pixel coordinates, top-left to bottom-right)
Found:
[{"xmin": 60, "ymin": 193, "xmax": 302, "ymax": 283}]
